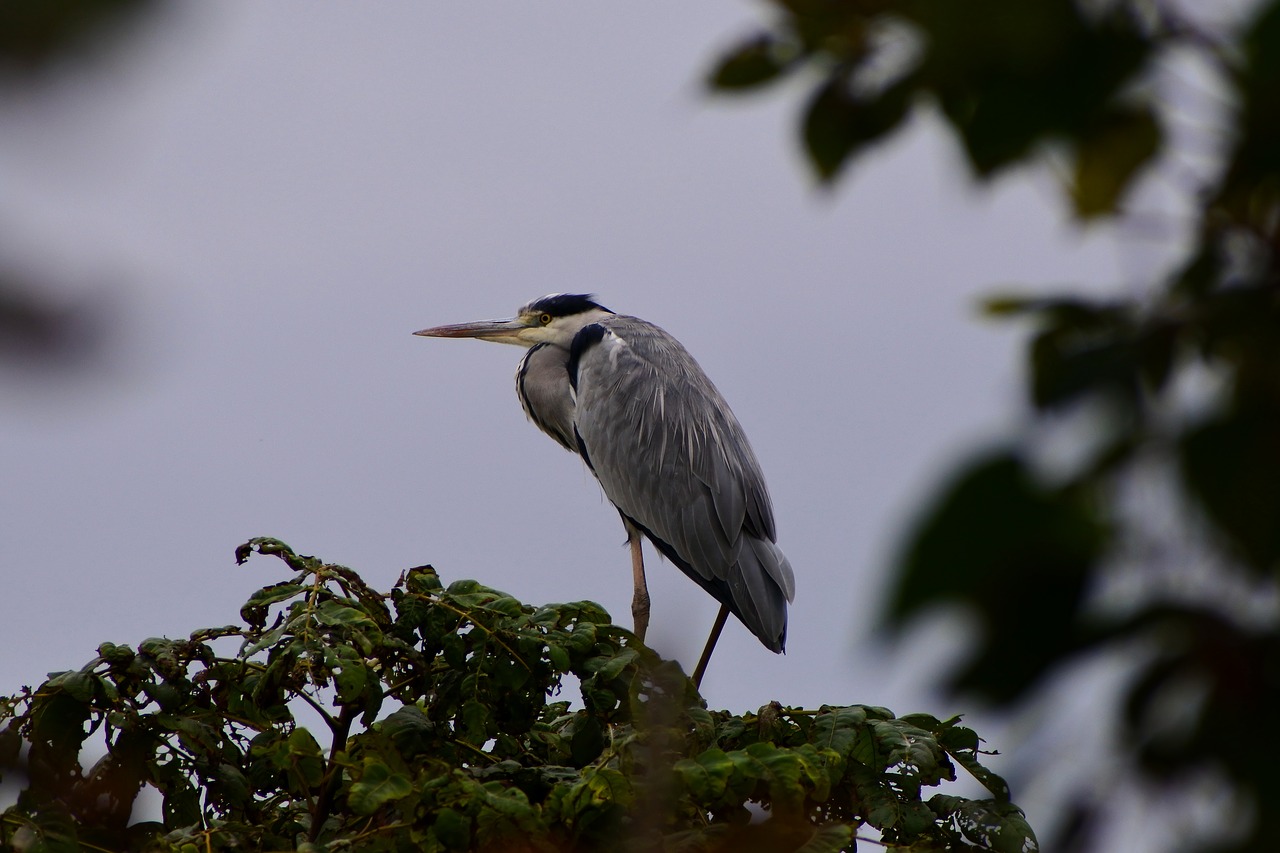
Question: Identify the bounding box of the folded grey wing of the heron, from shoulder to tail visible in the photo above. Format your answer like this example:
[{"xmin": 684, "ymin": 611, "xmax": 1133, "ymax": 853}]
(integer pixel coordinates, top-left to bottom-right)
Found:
[{"xmin": 571, "ymin": 316, "xmax": 795, "ymax": 651}]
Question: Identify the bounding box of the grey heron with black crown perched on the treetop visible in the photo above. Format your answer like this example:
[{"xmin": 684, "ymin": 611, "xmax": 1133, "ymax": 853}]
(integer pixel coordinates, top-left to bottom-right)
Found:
[{"xmin": 415, "ymin": 293, "xmax": 795, "ymax": 683}]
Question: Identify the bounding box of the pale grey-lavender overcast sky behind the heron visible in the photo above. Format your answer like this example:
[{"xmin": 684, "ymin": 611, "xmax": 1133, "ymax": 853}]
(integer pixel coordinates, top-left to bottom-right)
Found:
[{"xmin": 0, "ymin": 0, "xmax": 1187, "ymax": 845}]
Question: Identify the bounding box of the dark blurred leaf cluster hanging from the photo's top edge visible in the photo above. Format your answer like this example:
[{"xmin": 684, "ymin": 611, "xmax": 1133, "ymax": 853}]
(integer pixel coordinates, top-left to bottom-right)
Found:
[{"xmin": 708, "ymin": 0, "xmax": 1218, "ymax": 216}]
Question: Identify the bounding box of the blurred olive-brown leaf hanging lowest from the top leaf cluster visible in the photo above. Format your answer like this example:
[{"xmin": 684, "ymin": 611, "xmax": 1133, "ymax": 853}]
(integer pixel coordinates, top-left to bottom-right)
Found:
[{"xmin": 1071, "ymin": 105, "xmax": 1161, "ymax": 219}]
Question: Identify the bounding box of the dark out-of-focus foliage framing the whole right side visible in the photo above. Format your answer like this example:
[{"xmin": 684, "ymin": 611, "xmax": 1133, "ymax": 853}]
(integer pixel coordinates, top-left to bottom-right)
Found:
[{"xmin": 709, "ymin": 0, "xmax": 1280, "ymax": 850}]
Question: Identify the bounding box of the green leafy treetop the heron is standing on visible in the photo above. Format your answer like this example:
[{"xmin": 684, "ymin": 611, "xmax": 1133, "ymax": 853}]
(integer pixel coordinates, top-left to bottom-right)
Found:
[{"xmin": 0, "ymin": 539, "xmax": 1038, "ymax": 853}]
